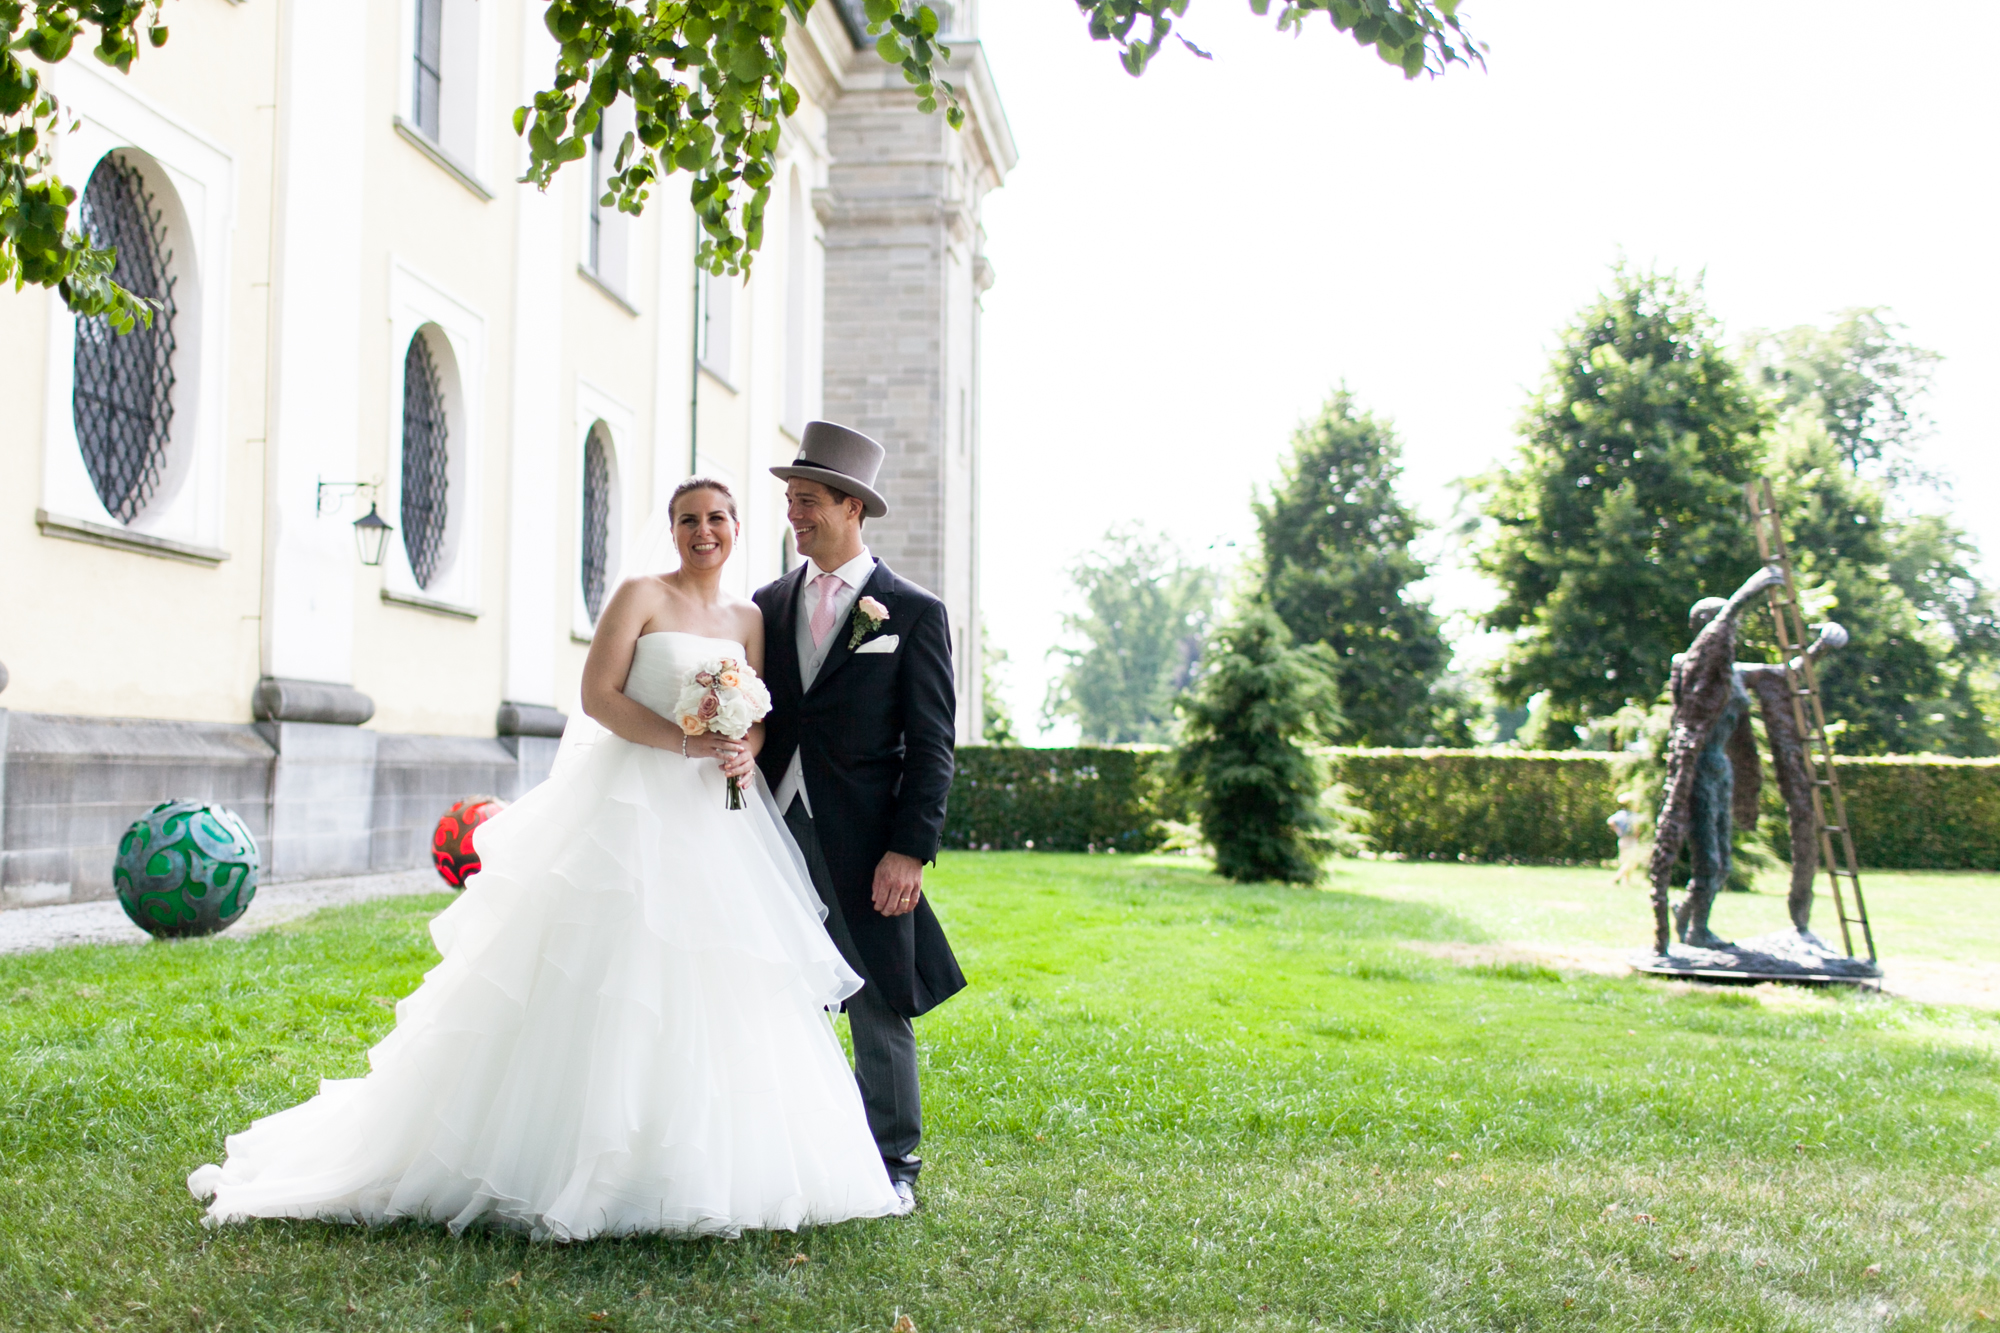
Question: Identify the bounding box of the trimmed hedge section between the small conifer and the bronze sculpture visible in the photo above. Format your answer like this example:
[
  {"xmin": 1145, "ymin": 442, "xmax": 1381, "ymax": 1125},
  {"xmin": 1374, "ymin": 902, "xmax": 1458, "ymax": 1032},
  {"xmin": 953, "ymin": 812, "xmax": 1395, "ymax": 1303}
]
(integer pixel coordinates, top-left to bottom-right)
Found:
[{"xmin": 1330, "ymin": 749, "xmax": 1618, "ymax": 865}]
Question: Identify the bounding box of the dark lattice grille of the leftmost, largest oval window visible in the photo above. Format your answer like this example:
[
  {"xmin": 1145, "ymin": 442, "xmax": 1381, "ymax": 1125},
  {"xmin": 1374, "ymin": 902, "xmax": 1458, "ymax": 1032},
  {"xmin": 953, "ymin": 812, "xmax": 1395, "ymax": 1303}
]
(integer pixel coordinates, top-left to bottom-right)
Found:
[{"xmin": 70, "ymin": 158, "xmax": 176, "ymax": 522}]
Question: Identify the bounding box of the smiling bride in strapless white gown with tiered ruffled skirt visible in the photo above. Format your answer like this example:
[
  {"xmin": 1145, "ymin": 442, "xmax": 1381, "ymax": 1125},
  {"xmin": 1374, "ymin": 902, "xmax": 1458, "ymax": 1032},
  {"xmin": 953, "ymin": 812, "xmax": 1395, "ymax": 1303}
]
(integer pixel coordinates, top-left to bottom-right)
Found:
[{"xmin": 188, "ymin": 478, "xmax": 902, "ymax": 1241}]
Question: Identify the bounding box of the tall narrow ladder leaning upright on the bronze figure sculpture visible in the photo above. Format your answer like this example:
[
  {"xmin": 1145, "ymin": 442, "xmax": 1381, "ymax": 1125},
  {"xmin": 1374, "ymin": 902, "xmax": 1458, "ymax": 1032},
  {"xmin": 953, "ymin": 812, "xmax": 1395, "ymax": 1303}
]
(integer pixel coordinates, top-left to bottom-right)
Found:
[{"xmin": 1744, "ymin": 476, "xmax": 1876, "ymax": 963}]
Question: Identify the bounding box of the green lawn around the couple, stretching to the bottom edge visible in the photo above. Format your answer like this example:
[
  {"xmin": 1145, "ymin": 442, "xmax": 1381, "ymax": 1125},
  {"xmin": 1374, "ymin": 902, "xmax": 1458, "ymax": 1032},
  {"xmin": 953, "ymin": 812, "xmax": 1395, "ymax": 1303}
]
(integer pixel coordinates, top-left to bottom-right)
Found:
[{"xmin": 0, "ymin": 853, "xmax": 2000, "ymax": 1333}]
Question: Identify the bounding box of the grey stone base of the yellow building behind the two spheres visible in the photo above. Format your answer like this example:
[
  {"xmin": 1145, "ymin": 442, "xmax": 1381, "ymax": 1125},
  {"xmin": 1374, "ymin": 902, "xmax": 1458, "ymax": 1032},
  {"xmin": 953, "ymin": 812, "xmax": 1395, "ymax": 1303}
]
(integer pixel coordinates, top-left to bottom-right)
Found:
[{"xmin": 0, "ymin": 709, "xmax": 558, "ymax": 907}]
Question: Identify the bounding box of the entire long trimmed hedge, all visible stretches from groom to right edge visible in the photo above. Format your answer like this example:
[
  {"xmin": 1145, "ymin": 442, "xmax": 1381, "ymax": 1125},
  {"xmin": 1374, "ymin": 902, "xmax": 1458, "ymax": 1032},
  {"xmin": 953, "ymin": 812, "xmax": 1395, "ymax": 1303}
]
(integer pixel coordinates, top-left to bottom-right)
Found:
[{"xmin": 944, "ymin": 745, "xmax": 2000, "ymax": 871}]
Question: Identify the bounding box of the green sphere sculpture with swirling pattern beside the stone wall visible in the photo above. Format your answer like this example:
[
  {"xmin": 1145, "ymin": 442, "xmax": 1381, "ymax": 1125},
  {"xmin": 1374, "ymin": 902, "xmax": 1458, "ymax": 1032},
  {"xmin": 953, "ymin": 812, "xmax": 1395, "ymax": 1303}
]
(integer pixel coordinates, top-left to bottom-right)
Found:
[{"xmin": 112, "ymin": 801, "xmax": 258, "ymax": 939}]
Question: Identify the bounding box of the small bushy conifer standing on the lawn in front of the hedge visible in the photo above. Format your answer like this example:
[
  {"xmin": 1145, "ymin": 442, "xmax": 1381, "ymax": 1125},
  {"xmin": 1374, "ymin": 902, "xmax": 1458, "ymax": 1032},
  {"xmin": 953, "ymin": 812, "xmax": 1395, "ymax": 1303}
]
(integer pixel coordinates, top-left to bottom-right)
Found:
[{"xmin": 1178, "ymin": 602, "xmax": 1340, "ymax": 885}]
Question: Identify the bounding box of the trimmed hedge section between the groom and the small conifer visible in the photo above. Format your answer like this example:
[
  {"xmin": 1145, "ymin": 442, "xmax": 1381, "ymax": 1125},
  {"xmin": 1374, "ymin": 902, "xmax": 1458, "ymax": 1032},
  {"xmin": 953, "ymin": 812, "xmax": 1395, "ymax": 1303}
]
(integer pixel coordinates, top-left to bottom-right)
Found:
[{"xmin": 944, "ymin": 745, "xmax": 1186, "ymax": 853}]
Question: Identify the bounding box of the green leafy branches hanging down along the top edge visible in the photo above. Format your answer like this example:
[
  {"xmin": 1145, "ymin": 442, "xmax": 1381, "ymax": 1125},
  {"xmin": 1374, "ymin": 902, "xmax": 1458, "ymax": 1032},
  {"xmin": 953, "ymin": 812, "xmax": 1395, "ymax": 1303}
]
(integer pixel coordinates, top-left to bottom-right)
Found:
[{"xmin": 0, "ymin": 0, "xmax": 1484, "ymax": 308}]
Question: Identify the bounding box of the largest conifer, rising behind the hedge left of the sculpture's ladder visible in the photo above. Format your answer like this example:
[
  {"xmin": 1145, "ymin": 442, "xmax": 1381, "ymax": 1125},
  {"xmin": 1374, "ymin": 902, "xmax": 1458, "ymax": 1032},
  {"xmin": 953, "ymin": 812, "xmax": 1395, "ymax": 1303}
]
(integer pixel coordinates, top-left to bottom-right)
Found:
[{"xmin": 1478, "ymin": 268, "xmax": 1768, "ymax": 749}]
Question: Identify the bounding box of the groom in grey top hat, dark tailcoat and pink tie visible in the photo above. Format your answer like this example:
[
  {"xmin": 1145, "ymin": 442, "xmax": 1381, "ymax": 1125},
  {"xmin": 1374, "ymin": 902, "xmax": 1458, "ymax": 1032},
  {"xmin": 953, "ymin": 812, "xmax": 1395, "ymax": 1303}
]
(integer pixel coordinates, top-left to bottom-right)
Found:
[{"xmin": 754, "ymin": 420, "xmax": 966, "ymax": 1213}]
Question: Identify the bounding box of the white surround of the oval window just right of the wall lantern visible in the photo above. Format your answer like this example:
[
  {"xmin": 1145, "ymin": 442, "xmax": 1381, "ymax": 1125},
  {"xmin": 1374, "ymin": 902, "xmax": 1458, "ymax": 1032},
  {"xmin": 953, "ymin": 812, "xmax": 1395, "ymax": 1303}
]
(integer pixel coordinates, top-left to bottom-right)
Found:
[{"xmin": 382, "ymin": 258, "xmax": 486, "ymax": 618}]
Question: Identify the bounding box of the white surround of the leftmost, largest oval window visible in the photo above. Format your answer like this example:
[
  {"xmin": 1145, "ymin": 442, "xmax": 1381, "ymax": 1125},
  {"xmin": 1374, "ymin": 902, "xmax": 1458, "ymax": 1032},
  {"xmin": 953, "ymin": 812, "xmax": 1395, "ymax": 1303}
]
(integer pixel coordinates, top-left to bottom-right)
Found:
[{"xmin": 42, "ymin": 60, "xmax": 236, "ymax": 562}]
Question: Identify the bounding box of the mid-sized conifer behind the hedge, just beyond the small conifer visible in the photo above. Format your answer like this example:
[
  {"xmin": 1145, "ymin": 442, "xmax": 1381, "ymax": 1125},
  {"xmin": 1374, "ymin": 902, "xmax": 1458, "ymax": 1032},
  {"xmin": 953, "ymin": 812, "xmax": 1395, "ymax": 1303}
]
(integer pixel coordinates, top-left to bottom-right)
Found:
[{"xmin": 1252, "ymin": 388, "xmax": 1470, "ymax": 745}]
